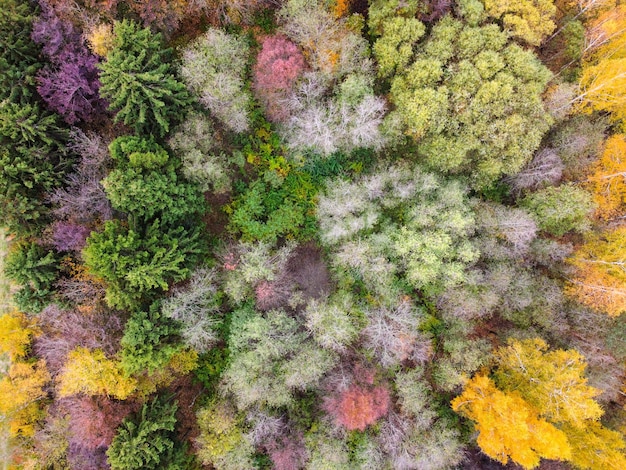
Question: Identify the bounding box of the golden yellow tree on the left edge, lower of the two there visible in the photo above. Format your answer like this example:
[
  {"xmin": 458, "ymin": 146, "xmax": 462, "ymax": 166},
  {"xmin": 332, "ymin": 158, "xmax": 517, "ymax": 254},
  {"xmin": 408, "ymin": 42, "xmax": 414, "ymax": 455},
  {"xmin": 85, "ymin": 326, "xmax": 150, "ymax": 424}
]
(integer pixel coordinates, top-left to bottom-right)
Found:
[{"xmin": 0, "ymin": 360, "xmax": 50, "ymax": 436}]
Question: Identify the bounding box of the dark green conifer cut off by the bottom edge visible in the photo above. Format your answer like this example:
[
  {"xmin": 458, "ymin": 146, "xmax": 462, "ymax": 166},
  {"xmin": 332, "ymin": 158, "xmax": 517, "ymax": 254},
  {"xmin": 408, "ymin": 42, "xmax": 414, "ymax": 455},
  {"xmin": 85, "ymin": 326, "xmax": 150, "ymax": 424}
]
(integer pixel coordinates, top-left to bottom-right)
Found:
[{"xmin": 107, "ymin": 397, "xmax": 189, "ymax": 470}]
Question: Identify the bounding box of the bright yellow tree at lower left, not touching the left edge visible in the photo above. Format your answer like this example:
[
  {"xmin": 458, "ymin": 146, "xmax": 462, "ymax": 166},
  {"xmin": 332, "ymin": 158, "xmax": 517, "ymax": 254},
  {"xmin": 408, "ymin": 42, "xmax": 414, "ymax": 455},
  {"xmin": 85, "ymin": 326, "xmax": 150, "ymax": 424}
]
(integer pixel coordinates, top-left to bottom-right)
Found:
[{"xmin": 57, "ymin": 348, "xmax": 137, "ymax": 400}]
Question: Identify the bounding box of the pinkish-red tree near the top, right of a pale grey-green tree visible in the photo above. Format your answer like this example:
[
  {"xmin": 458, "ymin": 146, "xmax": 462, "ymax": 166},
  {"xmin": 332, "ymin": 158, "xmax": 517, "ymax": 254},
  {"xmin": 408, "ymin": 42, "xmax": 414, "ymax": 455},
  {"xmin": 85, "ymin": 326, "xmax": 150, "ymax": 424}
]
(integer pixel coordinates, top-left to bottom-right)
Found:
[{"xmin": 254, "ymin": 36, "xmax": 306, "ymax": 122}]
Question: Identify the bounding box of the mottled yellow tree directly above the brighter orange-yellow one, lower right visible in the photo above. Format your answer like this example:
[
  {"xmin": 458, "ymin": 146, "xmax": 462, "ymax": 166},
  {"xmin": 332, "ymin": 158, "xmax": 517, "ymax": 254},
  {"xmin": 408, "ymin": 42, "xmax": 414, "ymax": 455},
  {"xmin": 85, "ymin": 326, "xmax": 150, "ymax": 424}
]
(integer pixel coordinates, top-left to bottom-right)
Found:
[{"xmin": 494, "ymin": 338, "xmax": 603, "ymax": 426}]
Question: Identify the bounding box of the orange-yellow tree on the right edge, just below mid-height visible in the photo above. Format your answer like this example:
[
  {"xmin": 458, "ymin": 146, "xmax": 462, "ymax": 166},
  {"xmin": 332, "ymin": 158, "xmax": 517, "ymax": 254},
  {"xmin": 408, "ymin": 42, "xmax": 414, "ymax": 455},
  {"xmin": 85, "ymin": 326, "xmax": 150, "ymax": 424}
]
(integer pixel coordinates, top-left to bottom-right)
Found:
[{"xmin": 565, "ymin": 227, "xmax": 626, "ymax": 316}]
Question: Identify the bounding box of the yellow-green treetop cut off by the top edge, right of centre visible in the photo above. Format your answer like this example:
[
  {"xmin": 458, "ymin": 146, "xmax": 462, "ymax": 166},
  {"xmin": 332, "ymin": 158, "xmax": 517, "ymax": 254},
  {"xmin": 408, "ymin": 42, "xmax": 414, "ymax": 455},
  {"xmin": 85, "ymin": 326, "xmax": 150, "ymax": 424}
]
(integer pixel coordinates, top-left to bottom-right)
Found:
[{"xmin": 484, "ymin": 0, "xmax": 556, "ymax": 46}]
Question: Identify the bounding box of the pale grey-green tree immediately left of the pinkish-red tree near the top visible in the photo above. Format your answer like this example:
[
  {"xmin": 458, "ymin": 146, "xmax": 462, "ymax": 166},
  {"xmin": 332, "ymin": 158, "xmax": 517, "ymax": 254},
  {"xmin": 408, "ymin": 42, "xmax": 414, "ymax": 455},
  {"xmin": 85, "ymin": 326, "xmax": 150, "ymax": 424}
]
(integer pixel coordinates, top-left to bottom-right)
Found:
[{"xmin": 181, "ymin": 28, "xmax": 251, "ymax": 132}]
